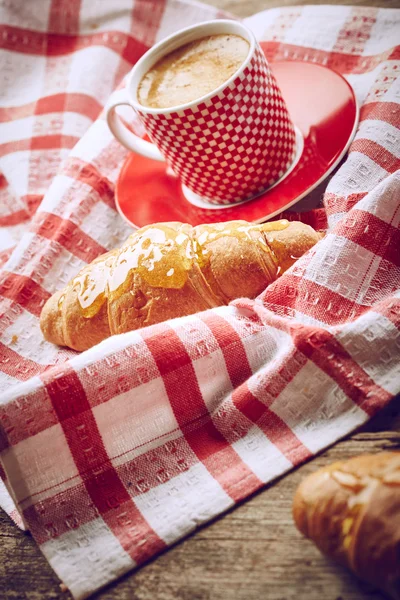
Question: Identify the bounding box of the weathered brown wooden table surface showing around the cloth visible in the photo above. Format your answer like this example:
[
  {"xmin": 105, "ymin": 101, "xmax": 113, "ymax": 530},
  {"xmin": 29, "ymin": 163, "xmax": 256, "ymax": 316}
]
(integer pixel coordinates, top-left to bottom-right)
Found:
[{"xmin": 0, "ymin": 0, "xmax": 400, "ymax": 600}]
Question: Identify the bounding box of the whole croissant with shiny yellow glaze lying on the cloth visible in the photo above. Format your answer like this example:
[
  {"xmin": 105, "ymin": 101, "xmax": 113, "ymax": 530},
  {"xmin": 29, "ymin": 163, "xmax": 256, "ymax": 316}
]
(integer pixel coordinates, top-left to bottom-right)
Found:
[{"xmin": 40, "ymin": 220, "xmax": 320, "ymax": 350}]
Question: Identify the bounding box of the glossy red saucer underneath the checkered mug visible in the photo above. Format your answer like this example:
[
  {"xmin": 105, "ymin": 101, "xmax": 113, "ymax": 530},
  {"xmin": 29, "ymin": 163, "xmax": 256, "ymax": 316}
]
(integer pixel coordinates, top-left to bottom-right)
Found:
[{"xmin": 116, "ymin": 61, "xmax": 358, "ymax": 227}]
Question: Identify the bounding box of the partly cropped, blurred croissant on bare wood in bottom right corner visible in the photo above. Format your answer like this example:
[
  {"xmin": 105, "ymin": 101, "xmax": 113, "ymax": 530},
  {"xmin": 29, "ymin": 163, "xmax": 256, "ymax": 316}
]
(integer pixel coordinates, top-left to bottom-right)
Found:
[{"xmin": 293, "ymin": 452, "xmax": 400, "ymax": 599}]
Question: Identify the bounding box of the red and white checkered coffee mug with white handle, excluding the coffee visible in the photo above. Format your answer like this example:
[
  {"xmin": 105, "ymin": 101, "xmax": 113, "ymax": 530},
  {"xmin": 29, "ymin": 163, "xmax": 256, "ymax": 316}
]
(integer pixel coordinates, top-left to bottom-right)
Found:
[{"xmin": 106, "ymin": 20, "xmax": 296, "ymax": 204}]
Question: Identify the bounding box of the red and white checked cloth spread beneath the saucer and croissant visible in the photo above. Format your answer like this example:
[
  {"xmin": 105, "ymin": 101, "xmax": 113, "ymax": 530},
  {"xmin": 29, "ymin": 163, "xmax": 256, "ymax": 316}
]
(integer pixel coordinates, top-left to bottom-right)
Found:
[{"xmin": 0, "ymin": 0, "xmax": 400, "ymax": 598}]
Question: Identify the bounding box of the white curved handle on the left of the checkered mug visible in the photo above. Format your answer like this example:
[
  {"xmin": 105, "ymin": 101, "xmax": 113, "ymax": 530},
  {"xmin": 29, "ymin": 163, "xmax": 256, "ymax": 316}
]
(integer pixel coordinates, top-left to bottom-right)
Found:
[{"xmin": 105, "ymin": 88, "xmax": 164, "ymax": 161}]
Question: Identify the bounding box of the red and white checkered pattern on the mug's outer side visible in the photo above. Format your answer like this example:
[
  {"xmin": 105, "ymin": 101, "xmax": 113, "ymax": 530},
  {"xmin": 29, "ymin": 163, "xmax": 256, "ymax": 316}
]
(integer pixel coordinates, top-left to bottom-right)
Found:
[{"xmin": 139, "ymin": 46, "xmax": 295, "ymax": 204}]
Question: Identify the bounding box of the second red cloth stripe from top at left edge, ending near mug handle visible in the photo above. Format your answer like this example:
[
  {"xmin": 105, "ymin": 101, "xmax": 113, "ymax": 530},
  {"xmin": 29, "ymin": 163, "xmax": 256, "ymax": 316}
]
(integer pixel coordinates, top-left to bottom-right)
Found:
[{"xmin": 0, "ymin": 93, "xmax": 102, "ymax": 123}]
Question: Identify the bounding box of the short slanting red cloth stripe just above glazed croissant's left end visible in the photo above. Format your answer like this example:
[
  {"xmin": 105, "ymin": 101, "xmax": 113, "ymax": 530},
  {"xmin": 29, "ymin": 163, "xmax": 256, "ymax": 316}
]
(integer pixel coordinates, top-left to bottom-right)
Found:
[{"xmin": 32, "ymin": 212, "xmax": 107, "ymax": 263}]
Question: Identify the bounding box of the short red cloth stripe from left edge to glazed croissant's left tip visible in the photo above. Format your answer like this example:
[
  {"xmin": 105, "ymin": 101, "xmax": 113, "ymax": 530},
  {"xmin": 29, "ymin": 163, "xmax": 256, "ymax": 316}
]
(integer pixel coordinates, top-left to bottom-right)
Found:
[{"xmin": 0, "ymin": 271, "xmax": 51, "ymax": 317}]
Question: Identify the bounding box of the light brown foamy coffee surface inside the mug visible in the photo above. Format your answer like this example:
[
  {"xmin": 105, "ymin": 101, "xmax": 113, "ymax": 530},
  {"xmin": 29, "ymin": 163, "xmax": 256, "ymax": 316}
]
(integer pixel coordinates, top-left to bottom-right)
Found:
[{"xmin": 138, "ymin": 34, "xmax": 250, "ymax": 108}]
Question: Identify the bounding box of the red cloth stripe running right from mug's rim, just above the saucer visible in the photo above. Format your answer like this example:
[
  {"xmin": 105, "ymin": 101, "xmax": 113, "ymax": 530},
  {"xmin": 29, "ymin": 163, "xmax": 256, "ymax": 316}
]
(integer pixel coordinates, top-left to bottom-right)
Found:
[{"xmin": 261, "ymin": 41, "xmax": 400, "ymax": 74}]
